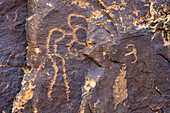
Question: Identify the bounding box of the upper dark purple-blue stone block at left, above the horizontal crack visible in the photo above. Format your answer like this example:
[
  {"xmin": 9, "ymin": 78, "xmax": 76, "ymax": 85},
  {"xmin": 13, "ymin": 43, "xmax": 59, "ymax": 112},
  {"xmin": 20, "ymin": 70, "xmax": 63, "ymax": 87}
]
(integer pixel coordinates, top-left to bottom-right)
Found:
[{"xmin": 0, "ymin": 0, "xmax": 27, "ymax": 67}]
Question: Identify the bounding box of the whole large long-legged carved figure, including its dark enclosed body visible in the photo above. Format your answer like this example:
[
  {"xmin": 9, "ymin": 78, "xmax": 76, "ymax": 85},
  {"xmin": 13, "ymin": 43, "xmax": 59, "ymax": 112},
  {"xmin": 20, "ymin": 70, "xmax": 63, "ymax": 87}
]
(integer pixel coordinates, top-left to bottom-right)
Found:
[{"xmin": 47, "ymin": 14, "xmax": 87, "ymax": 101}]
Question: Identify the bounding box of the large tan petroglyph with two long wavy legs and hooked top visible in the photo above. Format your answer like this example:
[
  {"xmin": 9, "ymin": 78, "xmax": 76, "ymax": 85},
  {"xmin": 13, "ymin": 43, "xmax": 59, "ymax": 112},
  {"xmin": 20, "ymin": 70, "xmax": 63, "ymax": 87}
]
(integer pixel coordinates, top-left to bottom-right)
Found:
[{"xmin": 46, "ymin": 14, "xmax": 86, "ymax": 101}]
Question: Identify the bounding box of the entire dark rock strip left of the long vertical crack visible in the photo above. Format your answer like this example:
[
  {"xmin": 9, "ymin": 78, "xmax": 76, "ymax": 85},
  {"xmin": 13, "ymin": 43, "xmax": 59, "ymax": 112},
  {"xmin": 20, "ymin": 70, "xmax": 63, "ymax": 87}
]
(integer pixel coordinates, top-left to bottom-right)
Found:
[{"xmin": 0, "ymin": 0, "xmax": 27, "ymax": 113}]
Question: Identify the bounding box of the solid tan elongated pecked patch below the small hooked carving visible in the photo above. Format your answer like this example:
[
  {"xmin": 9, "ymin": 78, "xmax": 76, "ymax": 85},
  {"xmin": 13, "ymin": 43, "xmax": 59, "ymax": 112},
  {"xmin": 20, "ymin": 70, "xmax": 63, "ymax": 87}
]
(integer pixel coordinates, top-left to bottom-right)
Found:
[{"xmin": 113, "ymin": 64, "xmax": 128, "ymax": 109}]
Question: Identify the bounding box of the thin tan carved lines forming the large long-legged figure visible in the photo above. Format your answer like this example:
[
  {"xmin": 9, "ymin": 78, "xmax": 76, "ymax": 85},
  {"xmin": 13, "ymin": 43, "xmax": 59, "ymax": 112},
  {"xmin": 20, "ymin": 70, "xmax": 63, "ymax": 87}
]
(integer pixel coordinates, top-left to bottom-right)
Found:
[{"xmin": 47, "ymin": 14, "xmax": 86, "ymax": 101}]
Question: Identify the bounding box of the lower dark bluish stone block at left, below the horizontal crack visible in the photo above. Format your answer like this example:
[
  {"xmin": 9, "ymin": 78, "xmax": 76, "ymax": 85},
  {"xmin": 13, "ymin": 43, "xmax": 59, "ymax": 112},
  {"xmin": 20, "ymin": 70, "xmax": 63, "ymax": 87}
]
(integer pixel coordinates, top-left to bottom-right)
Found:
[{"xmin": 0, "ymin": 66, "xmax": 24, "ymax": 113}]
